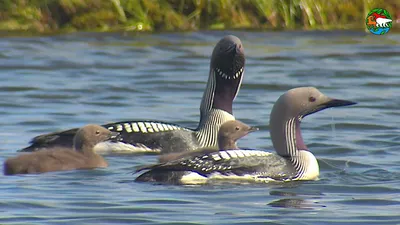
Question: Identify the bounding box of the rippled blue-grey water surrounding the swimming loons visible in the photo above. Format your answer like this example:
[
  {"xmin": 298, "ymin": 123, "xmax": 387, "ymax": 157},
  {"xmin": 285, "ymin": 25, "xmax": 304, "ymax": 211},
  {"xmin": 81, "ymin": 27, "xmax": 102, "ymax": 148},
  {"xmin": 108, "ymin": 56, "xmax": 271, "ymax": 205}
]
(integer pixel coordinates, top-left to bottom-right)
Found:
[{"xmin": 0, "ymin": 32, "xmax": 400, "ymax": 224}]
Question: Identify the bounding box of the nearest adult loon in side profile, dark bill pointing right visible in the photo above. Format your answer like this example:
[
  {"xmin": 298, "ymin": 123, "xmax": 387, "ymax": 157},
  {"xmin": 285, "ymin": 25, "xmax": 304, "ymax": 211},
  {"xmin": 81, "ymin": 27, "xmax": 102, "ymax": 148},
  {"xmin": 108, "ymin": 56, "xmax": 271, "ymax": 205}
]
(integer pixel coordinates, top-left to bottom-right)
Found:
[{"xmin": 136, "ymin": 87, "xmax": 356, "ymax": 184}]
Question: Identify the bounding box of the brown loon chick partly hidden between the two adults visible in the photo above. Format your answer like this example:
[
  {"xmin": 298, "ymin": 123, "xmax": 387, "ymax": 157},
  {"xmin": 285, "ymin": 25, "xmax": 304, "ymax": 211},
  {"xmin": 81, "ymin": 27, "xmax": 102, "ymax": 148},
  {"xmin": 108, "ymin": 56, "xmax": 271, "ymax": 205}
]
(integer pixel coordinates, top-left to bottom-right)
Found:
[{"xmin": 159, "ymin": 120, "xmax": 258, "ymax": 163}]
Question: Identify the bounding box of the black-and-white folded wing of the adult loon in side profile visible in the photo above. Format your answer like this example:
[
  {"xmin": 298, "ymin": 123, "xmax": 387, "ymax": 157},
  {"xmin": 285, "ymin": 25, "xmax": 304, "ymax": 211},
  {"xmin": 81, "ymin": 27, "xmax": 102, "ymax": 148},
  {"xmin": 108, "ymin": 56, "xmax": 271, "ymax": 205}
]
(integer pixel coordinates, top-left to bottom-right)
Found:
[{"xmin": 136, "ymin": 150, "xmax": 294, "ymax": 180}]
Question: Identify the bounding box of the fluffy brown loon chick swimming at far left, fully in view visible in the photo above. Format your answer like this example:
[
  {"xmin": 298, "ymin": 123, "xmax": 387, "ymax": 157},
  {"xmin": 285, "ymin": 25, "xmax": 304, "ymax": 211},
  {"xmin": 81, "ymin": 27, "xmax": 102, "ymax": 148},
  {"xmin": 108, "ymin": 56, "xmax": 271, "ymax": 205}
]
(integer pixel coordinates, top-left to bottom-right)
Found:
[{"xmin": 4, "ymin": 124, "xmax": 119, "ymax": 175}]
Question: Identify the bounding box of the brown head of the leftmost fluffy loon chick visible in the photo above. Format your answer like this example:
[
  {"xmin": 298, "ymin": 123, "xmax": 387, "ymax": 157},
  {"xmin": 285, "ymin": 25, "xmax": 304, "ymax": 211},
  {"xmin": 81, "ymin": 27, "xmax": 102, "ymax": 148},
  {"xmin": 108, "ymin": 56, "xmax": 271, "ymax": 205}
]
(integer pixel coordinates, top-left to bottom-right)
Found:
[{"xmin": 73, "ymin": 124, "xmax": 120, "ymax": 153}]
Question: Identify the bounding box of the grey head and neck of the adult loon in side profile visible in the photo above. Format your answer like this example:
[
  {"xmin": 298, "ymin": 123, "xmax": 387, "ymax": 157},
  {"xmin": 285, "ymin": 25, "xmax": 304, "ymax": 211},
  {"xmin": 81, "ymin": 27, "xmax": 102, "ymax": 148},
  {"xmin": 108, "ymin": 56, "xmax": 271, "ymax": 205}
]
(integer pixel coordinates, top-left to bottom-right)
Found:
[{"xmin": 269, "ymin": 87, "xmax": 356, "ymax": 155}]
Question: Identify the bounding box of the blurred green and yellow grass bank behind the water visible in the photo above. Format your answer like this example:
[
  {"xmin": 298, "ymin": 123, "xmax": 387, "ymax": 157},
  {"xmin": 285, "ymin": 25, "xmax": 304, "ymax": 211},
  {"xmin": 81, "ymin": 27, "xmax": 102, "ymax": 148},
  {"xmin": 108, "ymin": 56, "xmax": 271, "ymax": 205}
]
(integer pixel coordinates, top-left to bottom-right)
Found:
[{"xmin": 0, "ymin": 0, "xmax": 400, "ymax": 32}]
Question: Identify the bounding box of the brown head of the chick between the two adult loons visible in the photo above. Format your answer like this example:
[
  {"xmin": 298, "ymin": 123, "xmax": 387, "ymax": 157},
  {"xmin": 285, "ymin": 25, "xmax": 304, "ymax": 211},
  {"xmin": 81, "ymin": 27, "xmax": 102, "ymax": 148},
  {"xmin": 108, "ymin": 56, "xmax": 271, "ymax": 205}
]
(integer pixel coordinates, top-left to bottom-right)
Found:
[{"xmin": 218, "ymin": 120, "xmax": 258, "ymax": 150}]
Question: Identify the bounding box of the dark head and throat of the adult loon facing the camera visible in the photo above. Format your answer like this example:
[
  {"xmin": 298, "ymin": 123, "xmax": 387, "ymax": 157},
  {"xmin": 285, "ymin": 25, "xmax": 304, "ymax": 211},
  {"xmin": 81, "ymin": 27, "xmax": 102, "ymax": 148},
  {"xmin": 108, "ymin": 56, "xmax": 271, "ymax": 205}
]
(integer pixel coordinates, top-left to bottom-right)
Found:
[{"xmin": 210, "ymin": 35, "xmax": 245, "ymax": 114}]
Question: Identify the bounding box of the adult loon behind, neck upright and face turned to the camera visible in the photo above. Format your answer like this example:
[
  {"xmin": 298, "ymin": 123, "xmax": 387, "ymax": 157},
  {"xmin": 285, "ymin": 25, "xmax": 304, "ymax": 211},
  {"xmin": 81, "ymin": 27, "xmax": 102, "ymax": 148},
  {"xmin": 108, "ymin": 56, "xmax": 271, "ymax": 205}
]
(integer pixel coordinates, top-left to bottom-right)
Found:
[{"xmin": 20, "ymin": 35, "xmax": 245, "ymax": 153}]
